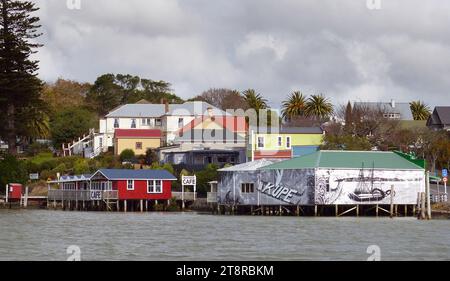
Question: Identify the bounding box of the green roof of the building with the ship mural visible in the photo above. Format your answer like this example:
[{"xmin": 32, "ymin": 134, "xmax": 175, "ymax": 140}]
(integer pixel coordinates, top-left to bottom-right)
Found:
[{"xmin": 261, "ymin": 150, "xmax": 424, "ymax": 170}]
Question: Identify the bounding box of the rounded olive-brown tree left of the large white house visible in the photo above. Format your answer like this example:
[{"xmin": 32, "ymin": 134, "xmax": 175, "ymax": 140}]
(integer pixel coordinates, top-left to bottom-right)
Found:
[{"xmin": 50, "ymin": 108, "xmax": 97, "ymax": 147}]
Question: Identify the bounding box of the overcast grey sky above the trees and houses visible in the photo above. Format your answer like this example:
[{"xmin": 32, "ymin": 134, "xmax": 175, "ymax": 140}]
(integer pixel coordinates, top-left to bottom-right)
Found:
[{"xmin": 36, "ymin": 0, "xmax": 450, "ymax": 107}]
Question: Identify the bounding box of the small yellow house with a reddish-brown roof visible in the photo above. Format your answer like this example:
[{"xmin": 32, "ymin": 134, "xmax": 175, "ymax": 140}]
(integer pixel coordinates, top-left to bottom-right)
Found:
[{"xmin": 114, "ymin": 129, "xmax": 162, "ymax": 155}]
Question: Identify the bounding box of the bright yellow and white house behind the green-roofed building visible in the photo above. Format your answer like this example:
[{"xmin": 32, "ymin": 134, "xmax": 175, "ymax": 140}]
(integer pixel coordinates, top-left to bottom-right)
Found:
[{"xmin": 250, "ymin": 127, "xmax": 324, "ymax": 160}]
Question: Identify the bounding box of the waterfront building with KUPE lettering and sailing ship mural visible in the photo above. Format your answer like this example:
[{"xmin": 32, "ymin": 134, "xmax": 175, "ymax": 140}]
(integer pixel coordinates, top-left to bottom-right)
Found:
[{"xmin": 218, "ymin": 151, "xmax": 425, "ymax": 214}]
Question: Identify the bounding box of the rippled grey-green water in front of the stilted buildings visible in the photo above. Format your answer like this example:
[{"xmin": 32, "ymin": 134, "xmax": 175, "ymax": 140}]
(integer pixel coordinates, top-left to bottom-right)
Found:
[{"xmin": 0, "ymin": 210, "xmax": 450, "ymax": 260}]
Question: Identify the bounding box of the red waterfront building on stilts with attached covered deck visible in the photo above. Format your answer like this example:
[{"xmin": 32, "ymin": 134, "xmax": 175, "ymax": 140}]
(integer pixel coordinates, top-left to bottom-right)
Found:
[{"xmin": 48, "ymin": 169, "xmax": 177, "ymax": 210}]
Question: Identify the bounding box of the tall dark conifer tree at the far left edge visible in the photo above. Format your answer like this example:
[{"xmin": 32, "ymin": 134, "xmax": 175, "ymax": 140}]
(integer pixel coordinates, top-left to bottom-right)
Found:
[{"xmin": 0, "ymin": 0, "xmax": 44, "ymax": 154}]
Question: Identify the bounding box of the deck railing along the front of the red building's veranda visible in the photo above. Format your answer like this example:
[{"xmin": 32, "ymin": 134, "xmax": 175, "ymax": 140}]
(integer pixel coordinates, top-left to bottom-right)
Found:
[{"xmin": 48, "ymin": 189, "xmax": 118, "ymax": 201}]
